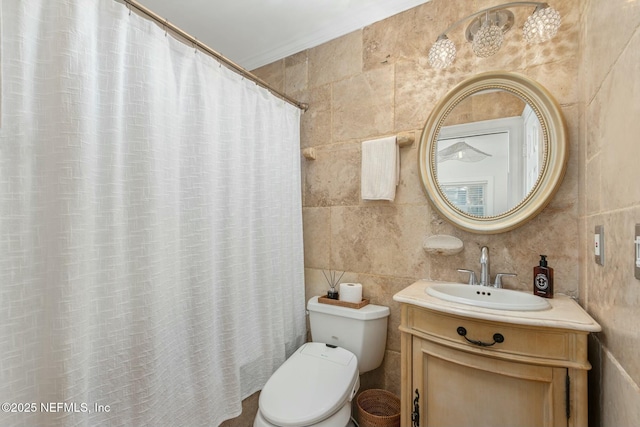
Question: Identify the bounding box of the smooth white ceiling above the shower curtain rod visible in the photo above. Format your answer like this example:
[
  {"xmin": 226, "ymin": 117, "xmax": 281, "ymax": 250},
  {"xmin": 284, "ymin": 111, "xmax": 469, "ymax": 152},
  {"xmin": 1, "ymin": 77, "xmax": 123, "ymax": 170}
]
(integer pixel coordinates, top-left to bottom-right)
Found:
[{"xmin": 138, "ymin": 0, "xmax": 429, "ymax": 70}]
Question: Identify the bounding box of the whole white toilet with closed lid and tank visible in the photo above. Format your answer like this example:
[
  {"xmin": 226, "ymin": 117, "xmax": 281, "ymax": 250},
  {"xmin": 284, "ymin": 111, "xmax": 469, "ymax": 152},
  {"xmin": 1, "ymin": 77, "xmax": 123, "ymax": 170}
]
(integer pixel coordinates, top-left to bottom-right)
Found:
[{"xmin": 253, "ymin": 296, "xmax": 389, "ymax": 427}]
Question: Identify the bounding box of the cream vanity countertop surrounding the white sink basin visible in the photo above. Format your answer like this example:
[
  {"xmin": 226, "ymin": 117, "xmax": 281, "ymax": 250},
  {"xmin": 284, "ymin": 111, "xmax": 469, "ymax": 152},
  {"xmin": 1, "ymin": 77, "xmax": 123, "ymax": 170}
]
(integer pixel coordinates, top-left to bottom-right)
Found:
[{"xmin": 393, "ymin": 280, "xmax": 601, "ymax": 332}]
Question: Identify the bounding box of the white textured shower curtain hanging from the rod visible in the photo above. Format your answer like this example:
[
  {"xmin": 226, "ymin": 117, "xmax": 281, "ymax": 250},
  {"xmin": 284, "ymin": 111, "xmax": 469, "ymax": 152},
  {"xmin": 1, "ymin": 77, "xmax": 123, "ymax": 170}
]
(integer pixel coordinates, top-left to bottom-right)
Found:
[{"xmin": 0, "ymin": 0, "xmax": 305, "ymax": 426}]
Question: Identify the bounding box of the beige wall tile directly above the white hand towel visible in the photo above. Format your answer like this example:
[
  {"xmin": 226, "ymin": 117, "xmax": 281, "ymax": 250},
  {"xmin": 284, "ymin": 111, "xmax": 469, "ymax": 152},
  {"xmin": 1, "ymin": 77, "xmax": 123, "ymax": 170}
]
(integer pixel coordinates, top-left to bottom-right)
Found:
[{"xmin": 332, "ymin": 67, "xmax": 394, "ymax": 141}]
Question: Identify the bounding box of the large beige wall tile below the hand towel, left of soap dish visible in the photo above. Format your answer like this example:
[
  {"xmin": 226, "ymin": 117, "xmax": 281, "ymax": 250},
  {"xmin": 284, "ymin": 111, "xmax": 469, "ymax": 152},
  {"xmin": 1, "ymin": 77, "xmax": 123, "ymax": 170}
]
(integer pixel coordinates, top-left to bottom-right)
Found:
[{"xmin": 331, "ymin": 204, "xmax": 427, "ymax": 278}]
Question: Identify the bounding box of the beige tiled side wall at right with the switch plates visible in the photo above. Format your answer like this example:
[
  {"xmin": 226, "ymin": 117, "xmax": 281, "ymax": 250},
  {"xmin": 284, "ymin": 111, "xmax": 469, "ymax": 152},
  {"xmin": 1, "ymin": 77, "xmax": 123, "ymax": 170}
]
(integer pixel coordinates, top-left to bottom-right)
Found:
[{"xmin": 579, "ymin": 0, "xmax": 640, "ymax": 427}]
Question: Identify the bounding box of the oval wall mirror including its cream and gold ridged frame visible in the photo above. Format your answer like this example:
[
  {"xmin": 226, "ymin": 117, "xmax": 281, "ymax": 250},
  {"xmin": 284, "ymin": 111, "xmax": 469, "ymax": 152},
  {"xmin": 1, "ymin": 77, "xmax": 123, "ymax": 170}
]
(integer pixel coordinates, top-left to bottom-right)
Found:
[{"xmin": 418, "ymin": 72, "xmax": 568, "ymax": 233}]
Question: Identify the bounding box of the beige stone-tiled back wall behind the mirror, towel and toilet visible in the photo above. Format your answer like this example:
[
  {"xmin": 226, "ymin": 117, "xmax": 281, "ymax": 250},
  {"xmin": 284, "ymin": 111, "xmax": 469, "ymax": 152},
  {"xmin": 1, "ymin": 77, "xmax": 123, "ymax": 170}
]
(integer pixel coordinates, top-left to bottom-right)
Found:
[{"xmin": 256, "ymin": 0, "xmax": 581, "ymax": 393}]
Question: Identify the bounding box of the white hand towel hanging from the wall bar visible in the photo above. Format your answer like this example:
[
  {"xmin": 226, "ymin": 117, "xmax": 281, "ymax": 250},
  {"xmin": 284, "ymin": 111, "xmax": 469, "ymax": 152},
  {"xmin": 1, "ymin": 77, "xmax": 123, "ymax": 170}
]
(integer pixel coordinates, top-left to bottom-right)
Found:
[{"xmin": 360, "ymin": 136, "xmax": 400, "ymax": 201}]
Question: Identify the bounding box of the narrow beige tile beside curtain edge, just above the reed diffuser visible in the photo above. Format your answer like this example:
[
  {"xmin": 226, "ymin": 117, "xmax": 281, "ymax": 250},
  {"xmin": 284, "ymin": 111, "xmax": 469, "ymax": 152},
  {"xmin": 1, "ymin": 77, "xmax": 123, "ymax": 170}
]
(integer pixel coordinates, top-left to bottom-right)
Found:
[{"xmin": 302, "ymin": 207, "xmax": 331, "ymax": 268}]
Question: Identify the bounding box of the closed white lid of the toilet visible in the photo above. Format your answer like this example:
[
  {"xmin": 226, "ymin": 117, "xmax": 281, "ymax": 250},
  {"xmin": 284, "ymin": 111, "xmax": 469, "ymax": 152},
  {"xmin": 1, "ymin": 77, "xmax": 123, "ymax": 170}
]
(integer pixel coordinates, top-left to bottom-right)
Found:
[{"xmin": 259, "ymin": 342, "xmax": 358, "ymax": 427}]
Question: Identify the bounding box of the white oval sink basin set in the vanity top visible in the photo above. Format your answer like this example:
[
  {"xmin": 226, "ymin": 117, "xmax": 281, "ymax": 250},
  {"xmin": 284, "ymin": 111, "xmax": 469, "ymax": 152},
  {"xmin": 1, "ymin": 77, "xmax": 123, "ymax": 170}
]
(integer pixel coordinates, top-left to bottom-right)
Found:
[{"xmin": 425, "ymin": 283, "xmax": 551, "ymax": 311}]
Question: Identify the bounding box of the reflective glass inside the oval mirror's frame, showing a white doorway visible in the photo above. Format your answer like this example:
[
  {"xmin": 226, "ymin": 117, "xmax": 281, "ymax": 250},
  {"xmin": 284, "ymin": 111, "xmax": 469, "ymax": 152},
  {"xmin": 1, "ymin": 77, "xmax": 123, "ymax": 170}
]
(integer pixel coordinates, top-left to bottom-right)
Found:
[{"xmin": 436, "ymin": 89, "xmax": 545, "ymax": 217}]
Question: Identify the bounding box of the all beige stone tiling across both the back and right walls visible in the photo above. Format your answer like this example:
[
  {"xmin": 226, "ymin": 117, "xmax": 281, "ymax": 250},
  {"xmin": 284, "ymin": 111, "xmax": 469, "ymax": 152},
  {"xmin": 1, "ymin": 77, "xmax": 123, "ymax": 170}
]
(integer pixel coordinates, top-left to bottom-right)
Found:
[{"xmin": 225, "ymin": 0, "xmax": 640, "ymax": 426}]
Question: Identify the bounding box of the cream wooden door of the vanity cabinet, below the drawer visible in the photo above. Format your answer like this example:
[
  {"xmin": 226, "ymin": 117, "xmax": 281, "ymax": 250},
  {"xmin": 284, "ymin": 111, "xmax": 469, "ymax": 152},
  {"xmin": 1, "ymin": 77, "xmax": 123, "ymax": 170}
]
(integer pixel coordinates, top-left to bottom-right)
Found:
[{"xmin": 412, "ymin": 337, "xmax": 568, "ymax": 427}]
